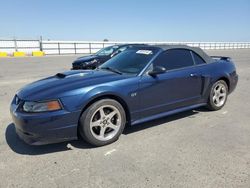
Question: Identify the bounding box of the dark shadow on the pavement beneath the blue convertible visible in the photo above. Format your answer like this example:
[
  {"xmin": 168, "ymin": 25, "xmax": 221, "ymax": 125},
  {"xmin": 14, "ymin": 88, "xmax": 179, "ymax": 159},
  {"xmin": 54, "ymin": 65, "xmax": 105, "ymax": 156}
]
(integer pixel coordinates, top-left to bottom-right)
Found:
[{"xmin": 5, "ymin": 108, "xmax": 206, "ymax": 155}]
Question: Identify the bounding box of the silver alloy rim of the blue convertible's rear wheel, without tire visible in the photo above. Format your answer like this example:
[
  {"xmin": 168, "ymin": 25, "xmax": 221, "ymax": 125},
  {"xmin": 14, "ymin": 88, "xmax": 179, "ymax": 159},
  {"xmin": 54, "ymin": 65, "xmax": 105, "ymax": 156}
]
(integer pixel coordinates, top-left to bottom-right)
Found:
[{"xmin": 212, "ymin": 83, "xmax": 227, "ymax": 107}]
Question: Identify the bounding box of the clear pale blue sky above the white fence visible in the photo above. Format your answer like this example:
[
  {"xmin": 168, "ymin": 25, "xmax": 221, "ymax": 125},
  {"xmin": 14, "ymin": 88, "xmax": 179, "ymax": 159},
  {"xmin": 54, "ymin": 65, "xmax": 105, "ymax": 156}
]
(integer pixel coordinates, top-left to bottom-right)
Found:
[{"xmin": 0, "ymin": 0, "xmax": 250, "ymax": 42}]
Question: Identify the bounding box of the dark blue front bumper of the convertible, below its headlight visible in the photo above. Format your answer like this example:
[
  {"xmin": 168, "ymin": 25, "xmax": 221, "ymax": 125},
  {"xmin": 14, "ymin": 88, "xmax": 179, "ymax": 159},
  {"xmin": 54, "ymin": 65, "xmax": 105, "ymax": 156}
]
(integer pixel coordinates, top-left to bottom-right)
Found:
[{"xmin": 10, "ymin": 99, "xmax": 80, "ymax": 145}]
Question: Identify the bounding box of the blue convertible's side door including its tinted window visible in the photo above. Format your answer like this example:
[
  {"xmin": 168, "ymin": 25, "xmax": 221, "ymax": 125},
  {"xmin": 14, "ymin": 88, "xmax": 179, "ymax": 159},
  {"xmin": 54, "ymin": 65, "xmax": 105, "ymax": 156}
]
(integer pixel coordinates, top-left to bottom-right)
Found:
[{"xmin": 139, "ymin": 49, "xmax": 203, "ymax": 116}]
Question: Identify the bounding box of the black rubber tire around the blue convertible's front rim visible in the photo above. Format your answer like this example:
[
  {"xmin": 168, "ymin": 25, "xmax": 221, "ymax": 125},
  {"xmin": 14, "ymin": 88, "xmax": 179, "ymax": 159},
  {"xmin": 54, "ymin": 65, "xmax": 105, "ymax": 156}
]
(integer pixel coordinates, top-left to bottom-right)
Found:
[{"xmin": 79, "ymin": 99, "xmax": 126, "ymax": 146}]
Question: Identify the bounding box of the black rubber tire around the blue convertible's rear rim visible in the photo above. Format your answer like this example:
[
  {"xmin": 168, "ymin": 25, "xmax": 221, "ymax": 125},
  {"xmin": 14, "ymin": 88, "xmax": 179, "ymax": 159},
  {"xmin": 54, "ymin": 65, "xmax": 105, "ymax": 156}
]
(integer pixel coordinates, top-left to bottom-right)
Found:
[{"xmin": 207, "ymin": 80, "xmax": 228, "ymax": 111}]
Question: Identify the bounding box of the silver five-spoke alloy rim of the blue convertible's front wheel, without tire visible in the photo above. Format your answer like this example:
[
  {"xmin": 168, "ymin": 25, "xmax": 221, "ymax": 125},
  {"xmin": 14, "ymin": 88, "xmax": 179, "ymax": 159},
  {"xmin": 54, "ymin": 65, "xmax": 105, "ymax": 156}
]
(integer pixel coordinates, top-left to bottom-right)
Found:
[{"xmin": 90, "ymin": 105, "xmax": 121, "ymax": 141}]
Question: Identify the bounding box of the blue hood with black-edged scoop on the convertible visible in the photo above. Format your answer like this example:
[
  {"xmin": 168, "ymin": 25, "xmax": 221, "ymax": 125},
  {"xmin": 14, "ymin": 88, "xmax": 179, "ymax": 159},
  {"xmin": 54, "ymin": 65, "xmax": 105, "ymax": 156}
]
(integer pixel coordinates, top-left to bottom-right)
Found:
[{"xmin": 17, "ymin": 70, "xmax": 128, "ymax": 101}]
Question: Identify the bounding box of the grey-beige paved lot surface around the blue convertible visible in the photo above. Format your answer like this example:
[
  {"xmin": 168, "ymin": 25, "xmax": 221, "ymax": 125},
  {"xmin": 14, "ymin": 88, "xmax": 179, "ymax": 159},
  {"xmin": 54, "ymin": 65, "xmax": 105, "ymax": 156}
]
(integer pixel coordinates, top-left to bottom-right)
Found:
[{"xmin": 0, "ymin": 49, "xmax": 250, "ymax": 188}]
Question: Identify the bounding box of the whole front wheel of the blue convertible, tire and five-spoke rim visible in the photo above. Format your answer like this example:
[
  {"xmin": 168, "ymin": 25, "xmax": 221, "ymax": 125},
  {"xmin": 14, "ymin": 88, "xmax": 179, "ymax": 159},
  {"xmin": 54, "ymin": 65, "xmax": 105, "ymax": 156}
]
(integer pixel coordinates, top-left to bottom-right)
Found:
[{"xmin": 79, "ymin": 99, "xmax": 126, "ymax": 146}]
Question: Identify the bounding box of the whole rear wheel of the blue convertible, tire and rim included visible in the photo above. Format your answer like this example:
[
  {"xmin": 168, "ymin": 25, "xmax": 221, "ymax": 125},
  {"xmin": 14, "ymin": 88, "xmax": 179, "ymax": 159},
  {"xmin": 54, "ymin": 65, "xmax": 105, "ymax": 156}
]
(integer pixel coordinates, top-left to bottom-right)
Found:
[{"xmin": 208, "ymin": 80, "xmax": 228, "ymax": 110}]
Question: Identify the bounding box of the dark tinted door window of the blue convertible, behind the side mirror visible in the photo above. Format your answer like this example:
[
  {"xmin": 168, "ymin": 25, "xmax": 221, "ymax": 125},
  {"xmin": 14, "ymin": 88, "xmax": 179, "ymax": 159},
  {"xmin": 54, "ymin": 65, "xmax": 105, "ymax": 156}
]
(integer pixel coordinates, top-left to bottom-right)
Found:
[{"xmin": 154, "ymin": 49, "xmax": 194, "ymax": 70}]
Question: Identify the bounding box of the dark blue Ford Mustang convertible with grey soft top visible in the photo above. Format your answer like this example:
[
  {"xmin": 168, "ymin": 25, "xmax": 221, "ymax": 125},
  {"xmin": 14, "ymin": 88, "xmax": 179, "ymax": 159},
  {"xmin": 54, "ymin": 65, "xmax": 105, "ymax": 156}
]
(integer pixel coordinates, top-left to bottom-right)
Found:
[{"xmin": 11, "ymin": 45, "xmax": 238, "ymax": 146}]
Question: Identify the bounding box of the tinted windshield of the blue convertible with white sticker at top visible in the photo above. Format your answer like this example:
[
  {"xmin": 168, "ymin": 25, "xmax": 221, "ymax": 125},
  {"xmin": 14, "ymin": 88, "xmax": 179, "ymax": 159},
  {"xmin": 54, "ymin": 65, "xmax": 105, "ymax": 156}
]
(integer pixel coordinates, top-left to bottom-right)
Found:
[{"xmin": 99, "ymin": 48, "xmax": 157, "ymax": 74}]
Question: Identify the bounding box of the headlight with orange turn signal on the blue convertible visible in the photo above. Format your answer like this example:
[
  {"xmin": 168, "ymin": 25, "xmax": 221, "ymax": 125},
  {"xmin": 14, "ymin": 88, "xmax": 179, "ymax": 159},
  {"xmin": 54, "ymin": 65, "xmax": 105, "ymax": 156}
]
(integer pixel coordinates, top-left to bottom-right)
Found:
[{"xmin": 23, "ymin": 100, "xmax": 62, "ymax": 112}]
